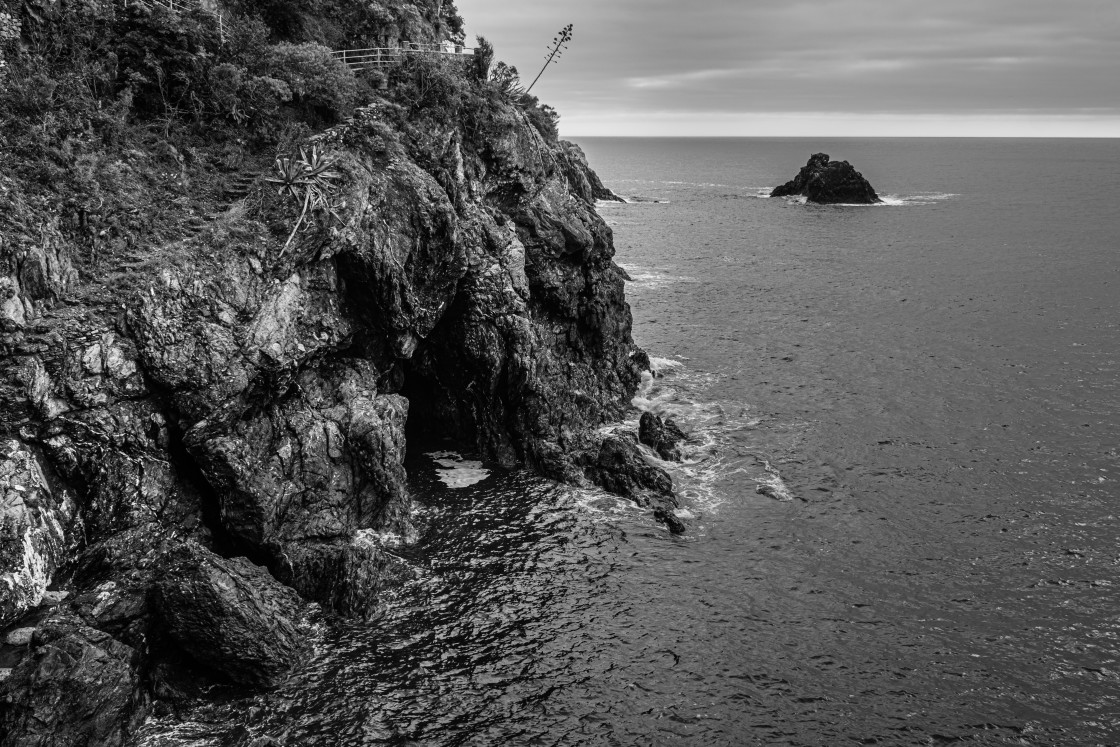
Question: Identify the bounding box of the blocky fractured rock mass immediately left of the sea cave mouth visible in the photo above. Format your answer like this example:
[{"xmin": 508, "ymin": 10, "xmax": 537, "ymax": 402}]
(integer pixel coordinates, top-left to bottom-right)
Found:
[{"xmin": 186, "ymin": 362, "xmax": 408, "ymax": 552}]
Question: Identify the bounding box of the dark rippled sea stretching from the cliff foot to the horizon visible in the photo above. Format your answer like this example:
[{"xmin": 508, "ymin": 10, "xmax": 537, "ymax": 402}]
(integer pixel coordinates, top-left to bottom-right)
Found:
[{"xmin": 143, "ymin": 138, "xmax": 1120, "ymax": 747}]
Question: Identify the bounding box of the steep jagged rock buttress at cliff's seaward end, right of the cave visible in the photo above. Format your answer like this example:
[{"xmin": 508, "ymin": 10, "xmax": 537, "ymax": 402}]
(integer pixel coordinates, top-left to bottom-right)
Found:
[{"xmin": 405, "ymin": 105, "xmax": 641, "ymax": 480}]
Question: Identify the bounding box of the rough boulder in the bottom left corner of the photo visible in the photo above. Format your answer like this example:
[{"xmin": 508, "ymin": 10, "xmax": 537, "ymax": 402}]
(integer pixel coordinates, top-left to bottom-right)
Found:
[{"xmin": 0, "ymin": 613, "xmax": 146, "ymax": 747}]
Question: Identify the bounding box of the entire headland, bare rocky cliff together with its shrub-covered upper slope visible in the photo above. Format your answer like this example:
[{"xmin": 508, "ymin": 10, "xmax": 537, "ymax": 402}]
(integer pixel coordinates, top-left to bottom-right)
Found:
[{"xmin": 0, "ymin": 0, "xmax": 684, "ymax": 746}]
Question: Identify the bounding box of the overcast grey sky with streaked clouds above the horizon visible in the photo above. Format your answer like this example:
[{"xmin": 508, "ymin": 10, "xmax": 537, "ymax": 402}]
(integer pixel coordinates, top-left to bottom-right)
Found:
[{"xmin": 457, "ymin": 0, "xmax": 1120, "ymax": 137}]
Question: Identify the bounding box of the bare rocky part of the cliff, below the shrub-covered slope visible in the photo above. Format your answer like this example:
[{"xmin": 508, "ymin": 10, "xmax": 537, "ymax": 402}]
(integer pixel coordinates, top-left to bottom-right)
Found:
[{"xmin": 0, "ymin": 61, "xmax": 681, "ymax": 745}]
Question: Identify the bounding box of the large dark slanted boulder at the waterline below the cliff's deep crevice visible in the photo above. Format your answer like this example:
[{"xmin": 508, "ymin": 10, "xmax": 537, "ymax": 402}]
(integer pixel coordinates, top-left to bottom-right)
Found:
[{"xmin": 156, "ymin": 542, "xmax": 310, "ymax": 688}]
